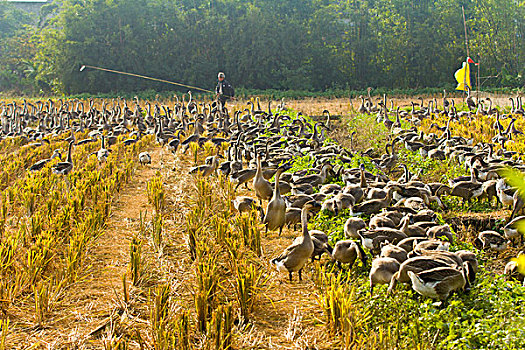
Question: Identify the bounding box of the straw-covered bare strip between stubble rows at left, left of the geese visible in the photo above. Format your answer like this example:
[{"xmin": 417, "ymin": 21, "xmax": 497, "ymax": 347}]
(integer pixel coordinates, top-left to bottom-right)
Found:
[{"xmin": 13, "ymin": 148, "xmax": 161, "ymax": 349}]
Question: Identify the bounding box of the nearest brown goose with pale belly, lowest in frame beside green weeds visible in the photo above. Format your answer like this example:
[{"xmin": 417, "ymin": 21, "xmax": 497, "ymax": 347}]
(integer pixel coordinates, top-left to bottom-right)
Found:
[{"xmin": 408, "ymin": 263, "xmax": 470, "ymax": 300}]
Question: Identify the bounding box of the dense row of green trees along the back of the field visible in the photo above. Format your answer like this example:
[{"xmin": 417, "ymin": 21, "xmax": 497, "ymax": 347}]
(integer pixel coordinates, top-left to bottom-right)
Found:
[{"xmin": 0, "ymin": 0, "xmax": 525, "ymax": 94}]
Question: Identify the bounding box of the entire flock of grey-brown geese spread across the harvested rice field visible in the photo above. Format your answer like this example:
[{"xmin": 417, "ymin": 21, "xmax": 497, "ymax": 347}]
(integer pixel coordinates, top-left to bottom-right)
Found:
[{"xmin": 0, "ymin": 94, "xmax": 525, "ymax": 300}]
